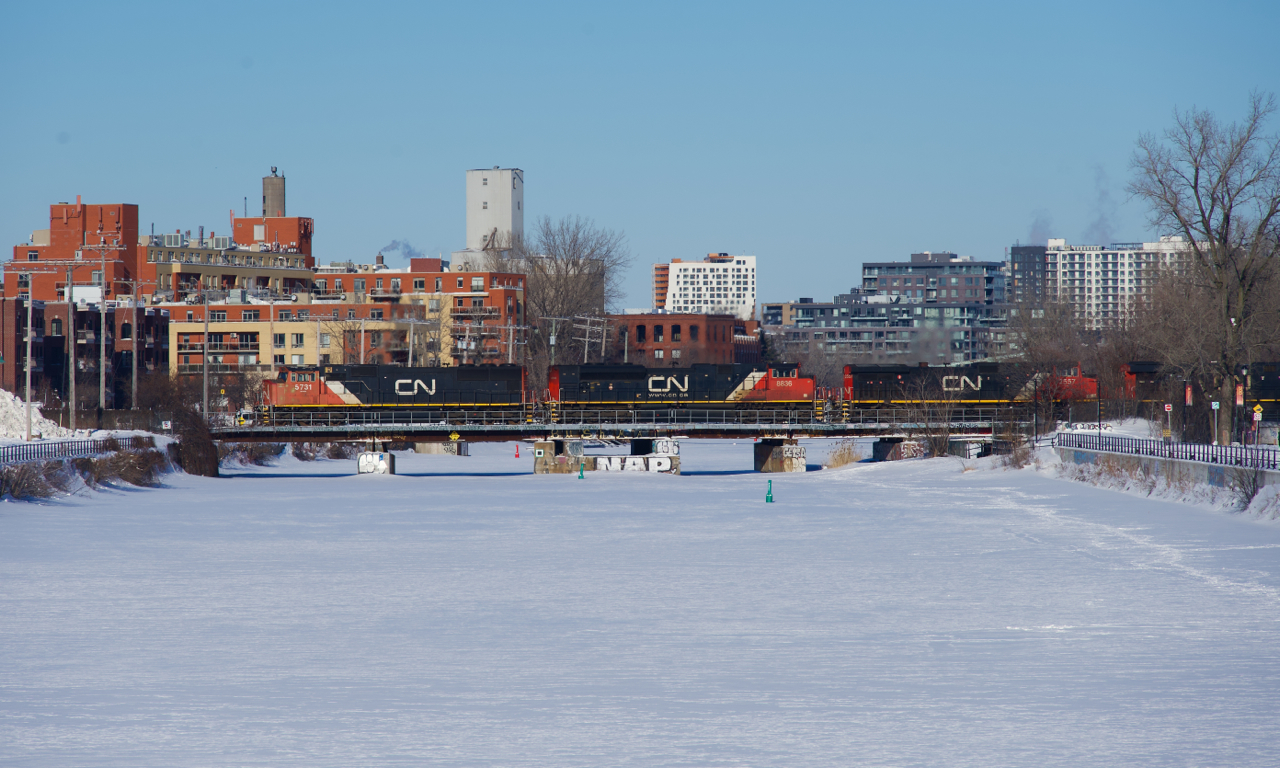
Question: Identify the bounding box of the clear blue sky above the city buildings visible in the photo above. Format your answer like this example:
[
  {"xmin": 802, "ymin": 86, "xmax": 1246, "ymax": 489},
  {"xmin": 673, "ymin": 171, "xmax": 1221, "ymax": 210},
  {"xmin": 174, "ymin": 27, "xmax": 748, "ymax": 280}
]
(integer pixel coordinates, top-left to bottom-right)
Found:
[{"xmin": 0, "ymin": 0, "xmax": 1280, "ymax": 306}]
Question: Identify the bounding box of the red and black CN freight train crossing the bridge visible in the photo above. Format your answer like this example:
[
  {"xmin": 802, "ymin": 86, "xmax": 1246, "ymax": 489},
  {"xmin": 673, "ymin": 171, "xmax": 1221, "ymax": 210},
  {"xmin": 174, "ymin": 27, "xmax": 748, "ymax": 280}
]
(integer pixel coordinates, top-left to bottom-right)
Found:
[{"xmin": 264, "ymin": 362, "xmax": 1280, "ymax": 415}]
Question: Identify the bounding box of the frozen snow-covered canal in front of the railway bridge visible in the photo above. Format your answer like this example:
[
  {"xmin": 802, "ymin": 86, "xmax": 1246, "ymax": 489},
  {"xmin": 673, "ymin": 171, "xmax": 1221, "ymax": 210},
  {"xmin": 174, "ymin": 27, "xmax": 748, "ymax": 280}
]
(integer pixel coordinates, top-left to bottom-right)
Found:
[{"xmin": 0, "ymin": 443, "xmax": 1280, "ymax": 767}]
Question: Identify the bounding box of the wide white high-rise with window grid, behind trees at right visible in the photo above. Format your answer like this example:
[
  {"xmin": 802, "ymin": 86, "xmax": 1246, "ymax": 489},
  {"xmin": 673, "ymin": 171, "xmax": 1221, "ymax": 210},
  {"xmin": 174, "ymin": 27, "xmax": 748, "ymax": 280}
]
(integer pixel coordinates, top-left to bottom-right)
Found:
[{"xmin": 1039, "ymin": 236, "xmax": 1190, "ymax": 328}]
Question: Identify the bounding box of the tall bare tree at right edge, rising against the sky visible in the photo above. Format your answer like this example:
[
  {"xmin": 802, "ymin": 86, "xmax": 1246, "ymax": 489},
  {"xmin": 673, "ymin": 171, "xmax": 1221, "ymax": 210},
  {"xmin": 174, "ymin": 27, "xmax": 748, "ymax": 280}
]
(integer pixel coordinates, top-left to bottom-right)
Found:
[{"xmin": 1129, "ymin": 93, "xmax": 1280, "ymax": 442}]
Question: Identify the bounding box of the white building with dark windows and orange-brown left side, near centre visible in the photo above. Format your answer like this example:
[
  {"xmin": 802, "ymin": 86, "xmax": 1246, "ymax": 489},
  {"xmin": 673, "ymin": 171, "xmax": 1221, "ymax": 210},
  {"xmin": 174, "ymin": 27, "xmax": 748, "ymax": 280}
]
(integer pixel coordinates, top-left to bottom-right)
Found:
[{"xmin": 653, "ymin": 253, "xmax": 755, "ymax": 320}]
